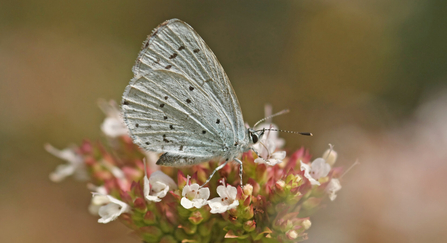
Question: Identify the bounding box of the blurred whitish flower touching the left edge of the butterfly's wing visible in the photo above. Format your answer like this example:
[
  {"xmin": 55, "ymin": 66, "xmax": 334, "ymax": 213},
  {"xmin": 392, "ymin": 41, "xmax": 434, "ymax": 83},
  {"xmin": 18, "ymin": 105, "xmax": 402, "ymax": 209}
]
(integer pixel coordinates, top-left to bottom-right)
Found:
[{"xmin": 98, "ymin": 100, "xmax": 129, "ymax": 138}]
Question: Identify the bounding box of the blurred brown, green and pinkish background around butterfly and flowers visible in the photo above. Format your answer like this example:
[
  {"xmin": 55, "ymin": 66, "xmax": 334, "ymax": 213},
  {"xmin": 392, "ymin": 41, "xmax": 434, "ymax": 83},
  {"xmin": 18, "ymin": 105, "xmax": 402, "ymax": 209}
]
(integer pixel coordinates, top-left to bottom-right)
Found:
[{"xmin": 0, "ymin": 0, "xmax": 447, "ymax": 243}]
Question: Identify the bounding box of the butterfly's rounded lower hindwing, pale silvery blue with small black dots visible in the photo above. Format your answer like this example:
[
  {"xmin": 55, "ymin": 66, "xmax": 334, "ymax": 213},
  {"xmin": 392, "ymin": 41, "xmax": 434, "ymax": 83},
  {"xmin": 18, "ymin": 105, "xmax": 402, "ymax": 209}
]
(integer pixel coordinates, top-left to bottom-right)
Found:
[{"xmin": 123, "ymin": 71, "xmax": 224, "ymax": 159}]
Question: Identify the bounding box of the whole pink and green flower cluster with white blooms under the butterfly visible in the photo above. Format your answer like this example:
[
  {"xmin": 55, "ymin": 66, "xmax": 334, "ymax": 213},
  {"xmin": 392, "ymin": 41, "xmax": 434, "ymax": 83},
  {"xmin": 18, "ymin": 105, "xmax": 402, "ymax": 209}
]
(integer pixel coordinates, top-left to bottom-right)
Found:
[{"xmin": 45, "ymin": 102, "xmax": 341, "ymax": 243}]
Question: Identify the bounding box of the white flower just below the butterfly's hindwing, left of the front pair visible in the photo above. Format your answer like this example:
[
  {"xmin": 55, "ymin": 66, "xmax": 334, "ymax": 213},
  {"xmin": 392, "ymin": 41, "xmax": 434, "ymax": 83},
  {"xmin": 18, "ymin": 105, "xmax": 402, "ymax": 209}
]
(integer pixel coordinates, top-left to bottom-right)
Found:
[{"xmin": 143, "ymin": 170, "xmax": 177, "ymax": 202}]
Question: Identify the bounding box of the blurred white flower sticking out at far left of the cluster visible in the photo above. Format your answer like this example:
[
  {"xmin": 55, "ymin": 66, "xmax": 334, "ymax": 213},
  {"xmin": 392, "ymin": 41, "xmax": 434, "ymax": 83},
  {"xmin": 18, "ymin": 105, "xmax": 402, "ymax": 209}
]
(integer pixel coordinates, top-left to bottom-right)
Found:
[{"xmin": 45, "ymin": 144, "xmax": 88, "ymax": 182}]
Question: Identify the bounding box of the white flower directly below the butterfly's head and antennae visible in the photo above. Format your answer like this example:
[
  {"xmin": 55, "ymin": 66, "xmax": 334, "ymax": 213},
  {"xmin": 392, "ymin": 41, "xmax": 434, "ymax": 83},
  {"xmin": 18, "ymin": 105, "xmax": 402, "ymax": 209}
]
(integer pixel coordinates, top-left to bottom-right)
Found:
[{"xmin": 253, "ymin": 138, "xmax": 286, "ymax": 166}]
